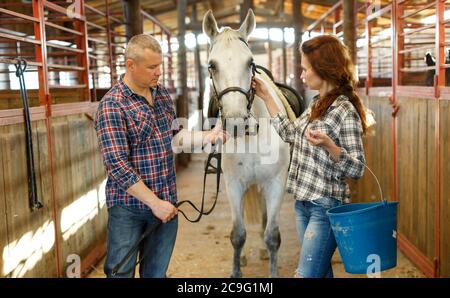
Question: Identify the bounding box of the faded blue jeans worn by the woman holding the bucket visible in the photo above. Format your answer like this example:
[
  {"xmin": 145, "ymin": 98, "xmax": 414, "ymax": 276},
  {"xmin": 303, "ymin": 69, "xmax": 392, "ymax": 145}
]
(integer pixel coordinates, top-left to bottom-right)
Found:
[{"xmin": 295, "ymin": 198, "xmax": 342, "ymax": 278}]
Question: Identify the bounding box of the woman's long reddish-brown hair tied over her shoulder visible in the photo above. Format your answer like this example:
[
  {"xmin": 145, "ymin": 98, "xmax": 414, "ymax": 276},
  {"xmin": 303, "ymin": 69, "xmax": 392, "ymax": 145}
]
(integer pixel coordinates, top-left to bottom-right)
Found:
[{"xmin": 300, "ymin": 35, "xmax": 367, "ymax": 132}]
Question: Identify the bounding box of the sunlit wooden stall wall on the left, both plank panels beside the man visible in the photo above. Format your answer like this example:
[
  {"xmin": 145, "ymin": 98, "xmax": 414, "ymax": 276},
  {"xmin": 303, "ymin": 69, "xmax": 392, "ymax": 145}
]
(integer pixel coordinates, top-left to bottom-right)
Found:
[{"xmin": 0, "ymin": 114, "xmax": 107, "ymax": 277}]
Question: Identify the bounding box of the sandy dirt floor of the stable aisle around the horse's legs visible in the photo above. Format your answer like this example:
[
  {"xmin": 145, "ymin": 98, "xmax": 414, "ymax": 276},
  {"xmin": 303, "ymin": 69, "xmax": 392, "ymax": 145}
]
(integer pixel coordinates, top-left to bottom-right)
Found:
[{"xmin": 89, "ymin": 154, "xmax": 424, "ymax": 278}]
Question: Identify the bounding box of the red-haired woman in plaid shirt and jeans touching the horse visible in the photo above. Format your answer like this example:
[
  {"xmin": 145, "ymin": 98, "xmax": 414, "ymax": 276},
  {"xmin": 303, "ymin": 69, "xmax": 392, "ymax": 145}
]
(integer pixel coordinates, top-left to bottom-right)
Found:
[{"xmin": 253, "ymin": 35, "xmax": 367, "ymax": 277}]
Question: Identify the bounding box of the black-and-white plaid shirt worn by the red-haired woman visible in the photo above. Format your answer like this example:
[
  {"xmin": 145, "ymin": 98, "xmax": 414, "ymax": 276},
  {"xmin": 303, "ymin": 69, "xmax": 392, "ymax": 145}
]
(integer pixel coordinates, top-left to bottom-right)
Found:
[{"xmin": 272, "ymin": 95, "xmax": 365, "ymax": 201}]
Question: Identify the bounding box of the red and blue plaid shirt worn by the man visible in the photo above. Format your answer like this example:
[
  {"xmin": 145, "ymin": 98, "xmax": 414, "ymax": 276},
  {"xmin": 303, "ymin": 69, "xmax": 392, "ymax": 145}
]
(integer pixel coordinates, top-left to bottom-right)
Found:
[{"xmin": 95, "ymin": 79, "xmax": 177, "ymax": 210}]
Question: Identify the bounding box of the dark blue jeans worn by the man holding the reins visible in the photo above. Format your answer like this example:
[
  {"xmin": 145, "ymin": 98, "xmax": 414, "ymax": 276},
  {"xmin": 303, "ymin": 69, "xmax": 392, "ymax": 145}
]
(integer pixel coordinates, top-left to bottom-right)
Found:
[{"xmin": 104, "ymin": 205, "xmax": 178, "ymax": 277}]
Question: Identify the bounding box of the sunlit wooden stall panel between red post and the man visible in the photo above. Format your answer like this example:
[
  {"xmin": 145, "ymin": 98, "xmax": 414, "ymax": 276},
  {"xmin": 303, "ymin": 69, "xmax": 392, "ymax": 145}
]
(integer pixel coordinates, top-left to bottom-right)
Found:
[{"xmin": 52, "ymin": 115, "xmax": 107, "ymax": 275}]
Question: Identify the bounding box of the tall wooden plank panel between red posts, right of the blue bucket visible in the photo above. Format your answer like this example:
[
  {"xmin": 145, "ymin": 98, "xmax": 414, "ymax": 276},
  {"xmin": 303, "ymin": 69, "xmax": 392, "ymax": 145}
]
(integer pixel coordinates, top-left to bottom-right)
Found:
[{"xmin": 397, "ymin": 97, "xmax": 436, "ymax": 261}]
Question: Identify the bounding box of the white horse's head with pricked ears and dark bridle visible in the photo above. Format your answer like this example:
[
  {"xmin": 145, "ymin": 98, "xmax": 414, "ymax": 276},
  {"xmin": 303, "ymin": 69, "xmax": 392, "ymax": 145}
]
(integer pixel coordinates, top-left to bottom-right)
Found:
[{"xmin": 203, "ymin": 9, "xmax": 255, "ymax": 119}]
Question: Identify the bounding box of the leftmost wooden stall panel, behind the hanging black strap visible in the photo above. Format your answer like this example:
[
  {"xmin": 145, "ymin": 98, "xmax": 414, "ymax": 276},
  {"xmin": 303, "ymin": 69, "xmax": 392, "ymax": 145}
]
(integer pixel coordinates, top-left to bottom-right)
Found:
[{"xmin": 0, "ymin": 121, "xmax": 57, "ymax": 277}]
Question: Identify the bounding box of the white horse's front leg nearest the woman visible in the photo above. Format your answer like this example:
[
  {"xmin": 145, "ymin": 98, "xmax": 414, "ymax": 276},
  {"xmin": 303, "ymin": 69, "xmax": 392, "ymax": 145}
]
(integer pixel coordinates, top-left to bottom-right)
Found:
[{"xmin": 262, "ymin": 177, "xmax": 285, "ymax": 277}]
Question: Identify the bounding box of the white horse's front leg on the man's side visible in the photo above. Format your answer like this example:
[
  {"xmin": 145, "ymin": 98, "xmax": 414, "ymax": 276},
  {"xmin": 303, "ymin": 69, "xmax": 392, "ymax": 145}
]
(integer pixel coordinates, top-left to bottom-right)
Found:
[{"xmin": 226, "ymin": 177, "xmax": 247, "ymax": 277}]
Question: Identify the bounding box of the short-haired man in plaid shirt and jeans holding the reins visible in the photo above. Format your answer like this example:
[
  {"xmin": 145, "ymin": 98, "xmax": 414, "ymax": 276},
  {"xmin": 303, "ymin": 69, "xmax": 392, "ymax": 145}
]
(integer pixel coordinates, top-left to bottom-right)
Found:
[{"xmin": 95, "ymin": 34, "xmax": 225, "ymax": 277}]
